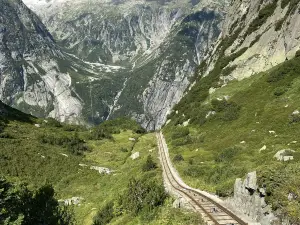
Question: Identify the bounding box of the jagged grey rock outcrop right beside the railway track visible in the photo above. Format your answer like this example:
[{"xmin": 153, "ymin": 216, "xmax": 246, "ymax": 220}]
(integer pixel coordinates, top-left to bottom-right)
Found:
[{"xmin": 226, "ymin": 172, "xmax": 277, "ymax": 225}]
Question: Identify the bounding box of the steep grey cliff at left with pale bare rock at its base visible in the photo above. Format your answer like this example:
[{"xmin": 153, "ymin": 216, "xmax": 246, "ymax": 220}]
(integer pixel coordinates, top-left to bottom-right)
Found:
[{"xmin": 0, "ymin": 0, "xmax": 82, "ymax": 122}]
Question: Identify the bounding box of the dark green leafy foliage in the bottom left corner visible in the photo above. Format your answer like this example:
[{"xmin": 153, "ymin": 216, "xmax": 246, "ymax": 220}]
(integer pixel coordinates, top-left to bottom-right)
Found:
[{"xmin": 0, "ymin": 178, "xmax": 75, "ymax": 225}]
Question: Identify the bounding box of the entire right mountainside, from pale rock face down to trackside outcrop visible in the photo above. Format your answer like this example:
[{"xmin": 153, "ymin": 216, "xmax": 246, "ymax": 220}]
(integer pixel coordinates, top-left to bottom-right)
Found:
[{"xmin": 164, "ymin": 1, "xmax": 300, "ymax": 224}]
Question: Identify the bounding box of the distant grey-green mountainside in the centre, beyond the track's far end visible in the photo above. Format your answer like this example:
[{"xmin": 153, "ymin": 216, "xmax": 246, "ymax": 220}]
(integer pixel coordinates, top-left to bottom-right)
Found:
[{"xmin": 24, "ymin": 0, "xmax": 227, "ymax": 129}]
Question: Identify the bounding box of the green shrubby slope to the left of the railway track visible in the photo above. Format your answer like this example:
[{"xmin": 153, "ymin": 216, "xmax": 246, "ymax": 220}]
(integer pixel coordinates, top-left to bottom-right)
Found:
[{"xmin": 0, "ymin": 102, "xmax": 201, "ymax": 225}]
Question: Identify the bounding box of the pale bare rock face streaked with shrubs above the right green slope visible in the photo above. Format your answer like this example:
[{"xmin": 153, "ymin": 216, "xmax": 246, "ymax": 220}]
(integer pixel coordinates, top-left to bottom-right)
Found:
[{"xmin": 206, "ymin": 0, "xmax": 300, "ymax": 83}]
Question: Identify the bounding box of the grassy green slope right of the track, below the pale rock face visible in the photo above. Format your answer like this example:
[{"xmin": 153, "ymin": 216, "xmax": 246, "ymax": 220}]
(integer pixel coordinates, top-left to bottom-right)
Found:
[{"xmin": 164, "ymin": 53, "xmax": 300, "ymax": 223}]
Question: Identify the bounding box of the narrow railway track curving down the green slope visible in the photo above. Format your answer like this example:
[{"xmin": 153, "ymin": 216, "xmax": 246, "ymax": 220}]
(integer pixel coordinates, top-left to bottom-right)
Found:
[{"xmin": 156, "ymin": 133, "xmax": 248, "ymax": 225}]
